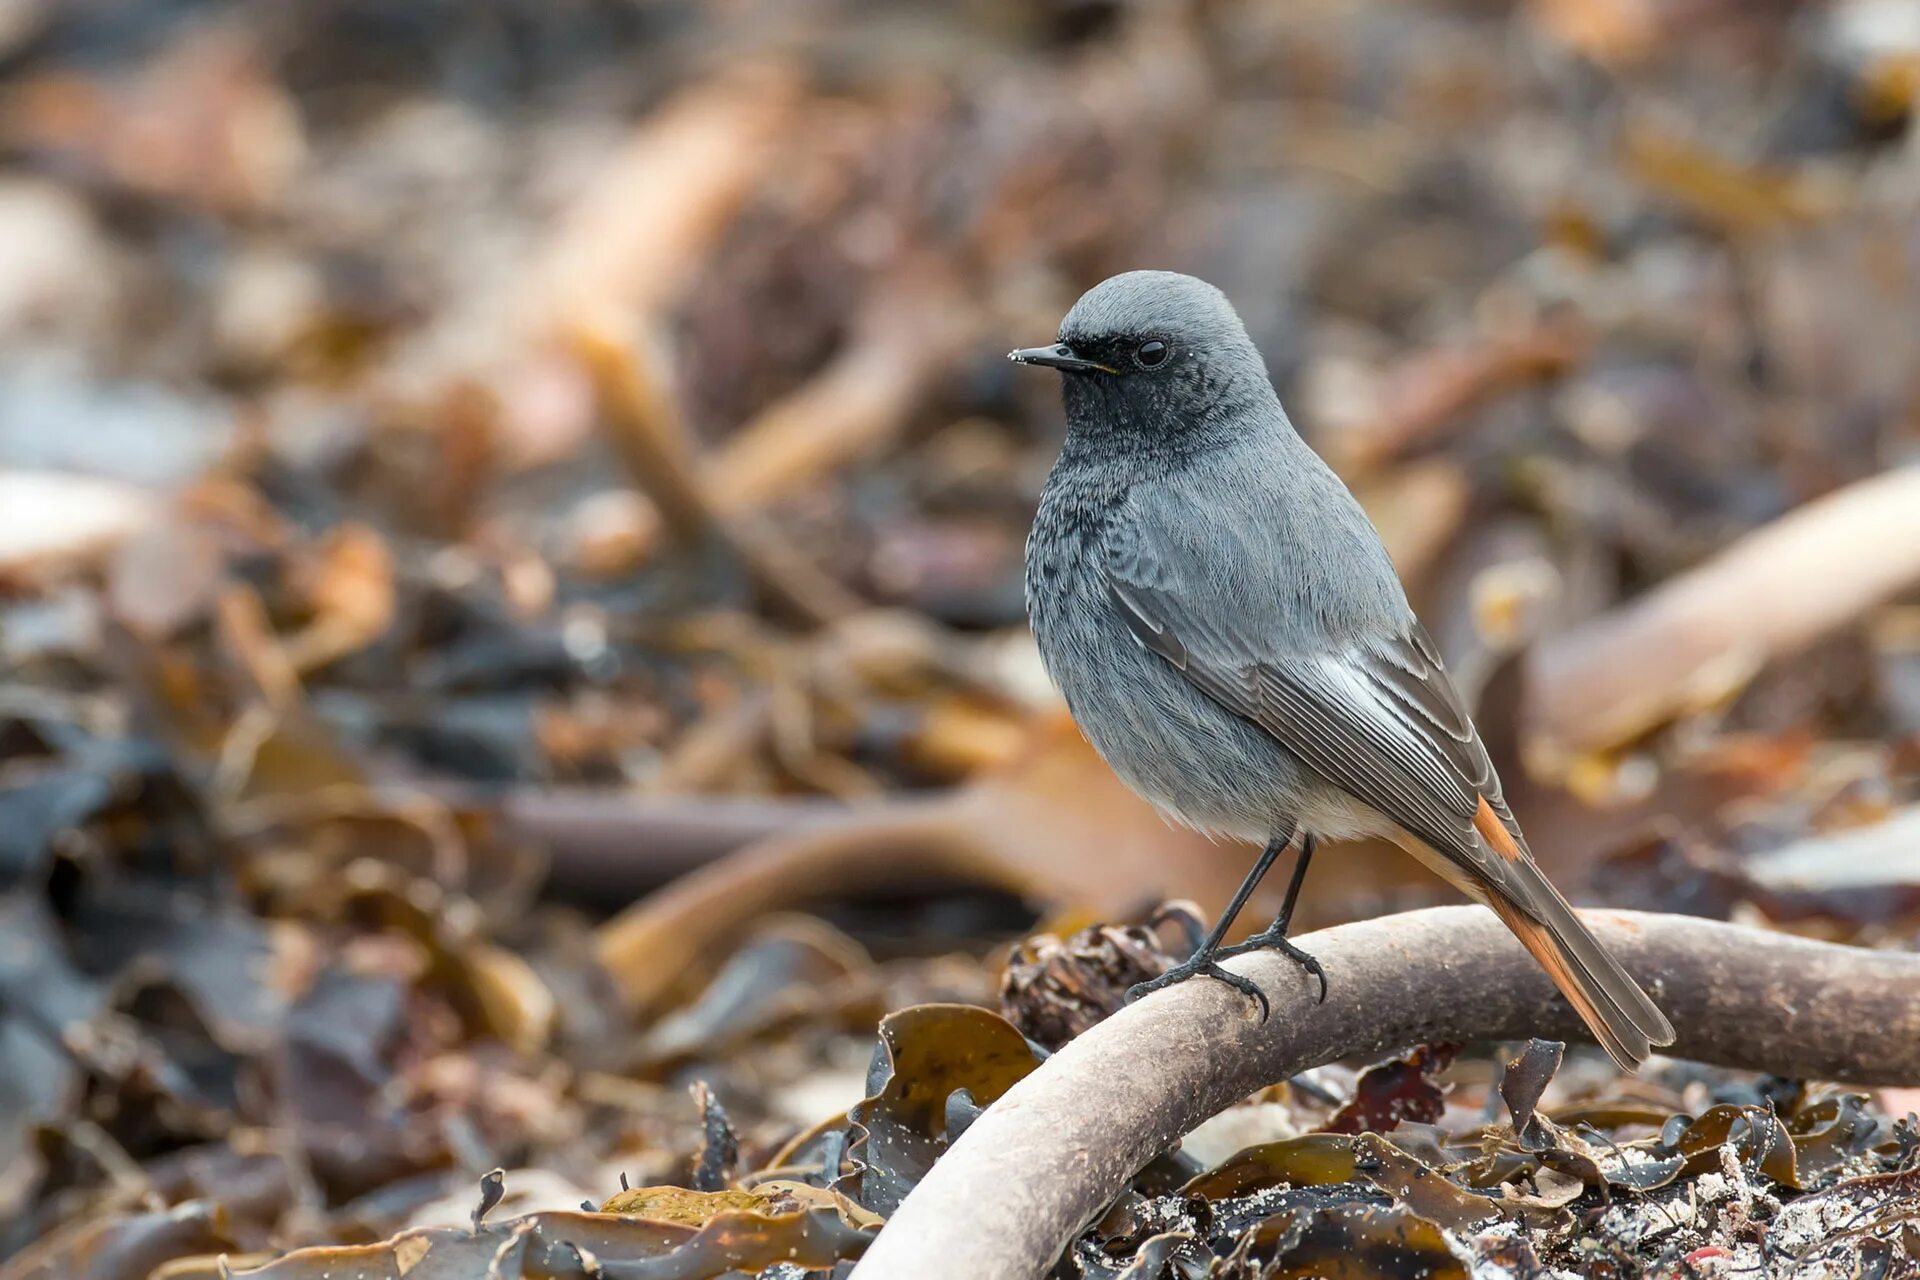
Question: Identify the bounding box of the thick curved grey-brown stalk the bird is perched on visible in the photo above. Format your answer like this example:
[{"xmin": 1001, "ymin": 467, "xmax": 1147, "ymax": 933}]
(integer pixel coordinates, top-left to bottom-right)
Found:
[{"xmin": 854, "ymin": 908, "xmax": 1920, "ymax": 1280}]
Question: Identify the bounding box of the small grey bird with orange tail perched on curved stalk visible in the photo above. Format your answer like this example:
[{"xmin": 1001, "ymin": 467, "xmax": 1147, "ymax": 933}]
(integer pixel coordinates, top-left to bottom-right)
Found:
[{"xmin": 1012, "ymin": 271, "xmax": 1674, "ymax": 1071}]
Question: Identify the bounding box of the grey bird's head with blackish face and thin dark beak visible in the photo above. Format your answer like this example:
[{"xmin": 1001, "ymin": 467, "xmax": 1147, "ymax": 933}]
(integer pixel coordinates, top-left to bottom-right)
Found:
[{"xmin": 1010, "ymin": 271, "xmax": 1273, "ymax": 445}]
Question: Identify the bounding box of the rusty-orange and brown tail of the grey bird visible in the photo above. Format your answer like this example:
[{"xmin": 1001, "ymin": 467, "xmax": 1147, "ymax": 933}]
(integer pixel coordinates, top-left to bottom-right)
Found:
[{"xmin": 1484, "ymin": 875, "xmax": 1674, "ymax": 1071}]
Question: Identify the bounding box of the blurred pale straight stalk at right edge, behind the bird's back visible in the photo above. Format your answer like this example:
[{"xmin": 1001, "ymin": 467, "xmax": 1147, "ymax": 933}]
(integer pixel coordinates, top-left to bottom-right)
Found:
[{"xmin": 1528, "ymin": 466, "xmax": 1920, "ymax": 766}]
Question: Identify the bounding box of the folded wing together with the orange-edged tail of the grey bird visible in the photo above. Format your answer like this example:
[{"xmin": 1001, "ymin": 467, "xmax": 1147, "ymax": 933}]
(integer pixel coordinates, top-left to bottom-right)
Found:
[{"xmin": 1104, "ymin": 506, "xmax": 1674, "ymax": 1069}]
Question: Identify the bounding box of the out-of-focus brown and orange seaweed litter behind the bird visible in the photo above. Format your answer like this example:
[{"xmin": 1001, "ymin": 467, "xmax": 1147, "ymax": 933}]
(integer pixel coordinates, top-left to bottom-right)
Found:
[{"xmin": 0, "ymin": 0, "xmax": 1920, "ymax": 1280}]
